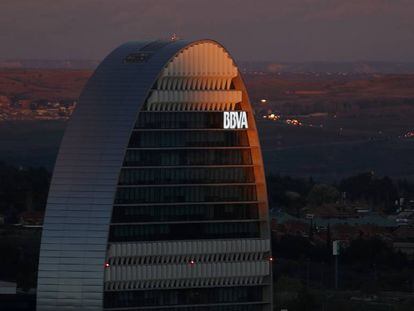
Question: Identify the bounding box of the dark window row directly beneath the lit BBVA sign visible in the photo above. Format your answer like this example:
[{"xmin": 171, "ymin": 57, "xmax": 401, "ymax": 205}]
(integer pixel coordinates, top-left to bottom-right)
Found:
[{"xmin": 128, "ymin": 130, "xmax": 249, "ymax": 148}]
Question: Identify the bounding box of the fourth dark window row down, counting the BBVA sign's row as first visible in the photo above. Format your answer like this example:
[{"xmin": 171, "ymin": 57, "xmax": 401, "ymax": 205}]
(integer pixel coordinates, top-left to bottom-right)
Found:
[{"xmin": 119, "ymin": 167, "xmax": 254, "ymax": 185}]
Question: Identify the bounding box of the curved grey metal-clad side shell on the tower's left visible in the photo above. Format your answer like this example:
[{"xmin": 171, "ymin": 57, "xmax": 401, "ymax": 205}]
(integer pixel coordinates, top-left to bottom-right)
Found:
[{"xmin": 37, "ymin": 41, "xmax": 190, "ymax": 311}]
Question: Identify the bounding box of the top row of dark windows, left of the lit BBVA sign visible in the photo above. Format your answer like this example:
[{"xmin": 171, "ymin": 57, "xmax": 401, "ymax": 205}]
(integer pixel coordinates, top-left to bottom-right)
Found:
[{"xmin": 135, "ymin": 111, "xmax": 238, "ymax": 129}]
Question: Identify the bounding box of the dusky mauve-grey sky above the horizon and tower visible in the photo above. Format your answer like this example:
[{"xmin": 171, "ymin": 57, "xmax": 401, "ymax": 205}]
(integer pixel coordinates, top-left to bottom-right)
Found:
[{"xmin": 0, "ymin": 0, "xmax": 414, "ymax": 61}]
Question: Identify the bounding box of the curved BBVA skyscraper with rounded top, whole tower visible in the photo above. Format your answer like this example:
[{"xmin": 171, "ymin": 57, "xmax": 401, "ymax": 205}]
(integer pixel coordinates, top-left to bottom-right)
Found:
[{"xmin": 37, "ymin": 40, "xmax": 272, "ymax": 311}]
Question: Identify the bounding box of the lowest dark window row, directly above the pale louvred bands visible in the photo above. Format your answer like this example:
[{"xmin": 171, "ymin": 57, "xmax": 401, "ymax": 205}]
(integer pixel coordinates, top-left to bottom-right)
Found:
[{"xmin": 109, "ymin": 222, "xmax": 260, "ymax": 242}]
